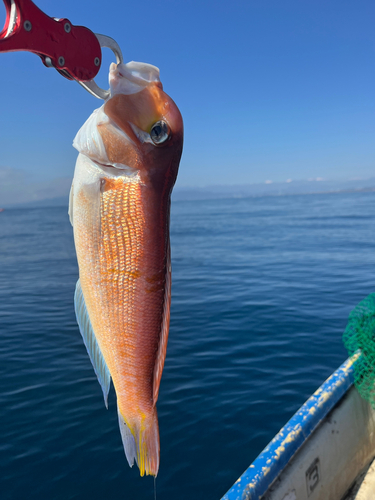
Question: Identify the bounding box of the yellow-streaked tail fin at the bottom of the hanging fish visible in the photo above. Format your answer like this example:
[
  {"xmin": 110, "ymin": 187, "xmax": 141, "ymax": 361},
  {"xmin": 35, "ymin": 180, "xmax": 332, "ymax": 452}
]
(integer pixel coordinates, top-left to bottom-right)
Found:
[{"xmin": 118, "ymin": 408, "xmax": 160, "ymax": 477}]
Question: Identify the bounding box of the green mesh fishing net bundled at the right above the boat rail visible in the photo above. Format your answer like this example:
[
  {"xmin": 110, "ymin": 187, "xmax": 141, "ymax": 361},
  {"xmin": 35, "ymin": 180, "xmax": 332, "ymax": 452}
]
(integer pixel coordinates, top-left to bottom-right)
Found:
[{"xmin": 343, "ymin": 293, "xmax": 375, "ymax": 409}]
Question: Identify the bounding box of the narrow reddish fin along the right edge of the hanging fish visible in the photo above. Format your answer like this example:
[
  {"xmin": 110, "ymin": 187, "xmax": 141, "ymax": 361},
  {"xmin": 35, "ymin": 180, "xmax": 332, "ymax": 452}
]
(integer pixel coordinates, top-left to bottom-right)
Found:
[{"xmin": 153, "ymin": 242, "xmax": 172, "ymax": 405}]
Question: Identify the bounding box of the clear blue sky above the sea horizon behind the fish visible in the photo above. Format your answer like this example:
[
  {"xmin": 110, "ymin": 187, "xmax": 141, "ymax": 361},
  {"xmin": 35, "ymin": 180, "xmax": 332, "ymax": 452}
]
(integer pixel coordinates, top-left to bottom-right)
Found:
[{"xmin": 0, "ymin": 0, "xmax": 375, "ymax": 191}]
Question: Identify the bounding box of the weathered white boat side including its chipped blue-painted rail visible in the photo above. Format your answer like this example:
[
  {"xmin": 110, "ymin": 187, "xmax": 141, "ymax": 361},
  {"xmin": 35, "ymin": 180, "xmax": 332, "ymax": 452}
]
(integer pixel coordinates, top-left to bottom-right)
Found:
[{"xmin": 222, "ymin": 354, "xmax": 375, "ymax": 500}]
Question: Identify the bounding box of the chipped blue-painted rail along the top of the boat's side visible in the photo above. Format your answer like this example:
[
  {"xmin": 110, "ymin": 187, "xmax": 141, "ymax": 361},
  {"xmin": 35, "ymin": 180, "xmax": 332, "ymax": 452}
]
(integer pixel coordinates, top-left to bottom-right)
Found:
[{"xmin": 222, "ymin": 354, "xmax": 359, "ymax": 500}]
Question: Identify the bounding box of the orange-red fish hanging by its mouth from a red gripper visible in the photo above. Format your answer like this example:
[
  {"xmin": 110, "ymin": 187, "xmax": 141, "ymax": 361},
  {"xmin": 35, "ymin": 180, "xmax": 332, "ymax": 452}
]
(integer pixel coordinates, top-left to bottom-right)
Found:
[{"xmin": 69, "ymin": 61, "xmax": 183, "ymax": 477}]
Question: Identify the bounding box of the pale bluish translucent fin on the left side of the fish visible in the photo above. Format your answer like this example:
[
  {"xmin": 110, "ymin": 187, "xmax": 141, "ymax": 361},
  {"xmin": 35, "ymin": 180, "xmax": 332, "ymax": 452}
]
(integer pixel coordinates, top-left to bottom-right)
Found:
[{"xmin": 74, "ymin": 280, "xmax": 111, "ymax": 408}]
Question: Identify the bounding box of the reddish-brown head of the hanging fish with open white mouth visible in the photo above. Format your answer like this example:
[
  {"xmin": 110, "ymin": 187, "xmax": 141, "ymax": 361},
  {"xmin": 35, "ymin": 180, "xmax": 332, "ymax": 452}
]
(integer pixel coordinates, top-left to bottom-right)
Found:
[{"xmin": 84, "ymin": 62, "xmax": 183, "ymax": 188}]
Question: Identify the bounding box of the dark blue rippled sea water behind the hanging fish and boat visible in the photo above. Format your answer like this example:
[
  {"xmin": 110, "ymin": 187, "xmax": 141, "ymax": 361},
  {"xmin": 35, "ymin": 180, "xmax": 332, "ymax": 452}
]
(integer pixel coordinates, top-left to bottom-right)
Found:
[{"xmin": 0, "ymin": 193, "xmax": 375, "ymax": 500}]
